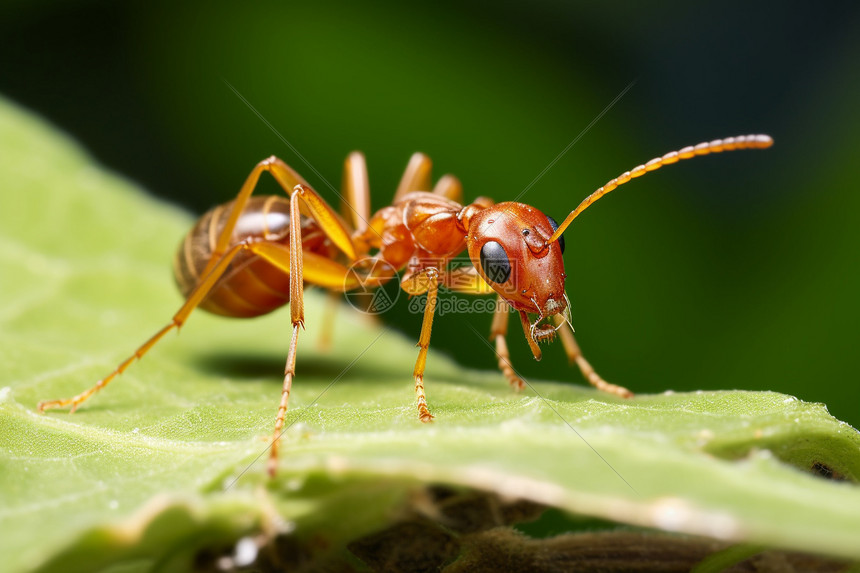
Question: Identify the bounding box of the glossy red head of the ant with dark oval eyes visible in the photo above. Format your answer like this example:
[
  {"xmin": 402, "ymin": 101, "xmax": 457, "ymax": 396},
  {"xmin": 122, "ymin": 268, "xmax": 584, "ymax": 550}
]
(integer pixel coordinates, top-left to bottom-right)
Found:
[{"xmin": 466, "ymin": 202, "xmax": 567, "ymax": 317}]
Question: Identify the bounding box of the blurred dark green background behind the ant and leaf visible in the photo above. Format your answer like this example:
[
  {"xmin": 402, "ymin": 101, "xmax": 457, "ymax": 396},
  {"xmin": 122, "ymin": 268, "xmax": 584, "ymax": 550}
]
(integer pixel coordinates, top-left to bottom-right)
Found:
[{"xmin": 0, "ymin": 0, "xmax": 860, "ymax": 426}]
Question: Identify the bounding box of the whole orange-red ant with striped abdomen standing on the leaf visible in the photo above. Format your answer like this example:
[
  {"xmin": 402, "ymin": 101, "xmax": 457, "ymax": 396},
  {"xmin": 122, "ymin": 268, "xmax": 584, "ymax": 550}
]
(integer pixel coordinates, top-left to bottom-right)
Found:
[{"xmin": 38, "ymin": 135, "xmax": 773, "ymax": 476}]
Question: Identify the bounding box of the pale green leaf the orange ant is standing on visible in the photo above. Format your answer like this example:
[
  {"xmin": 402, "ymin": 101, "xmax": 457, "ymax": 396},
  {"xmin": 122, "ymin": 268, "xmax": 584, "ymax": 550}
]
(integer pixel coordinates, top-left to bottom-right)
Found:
[{"xmin": 0, "ymin": 96, "xmax": 860, "ymax": 571}]
